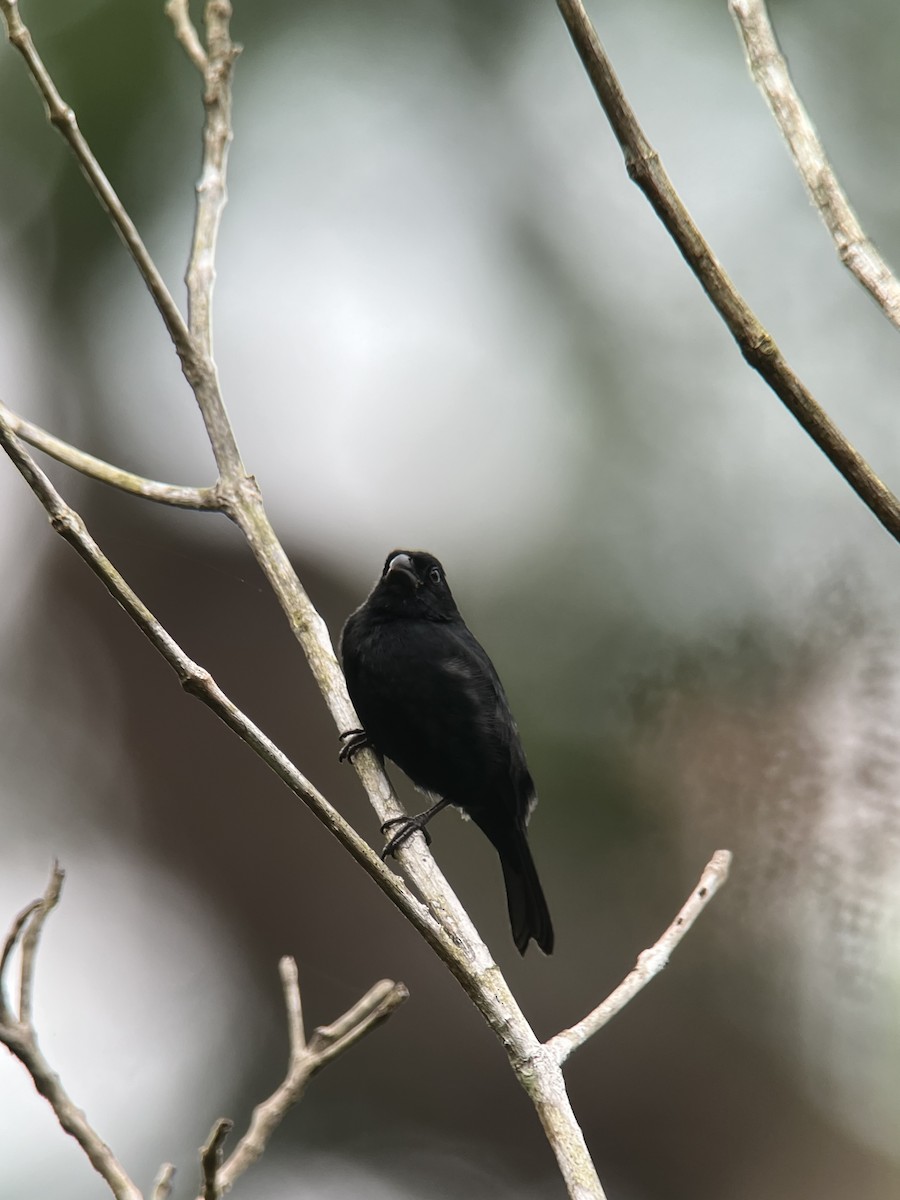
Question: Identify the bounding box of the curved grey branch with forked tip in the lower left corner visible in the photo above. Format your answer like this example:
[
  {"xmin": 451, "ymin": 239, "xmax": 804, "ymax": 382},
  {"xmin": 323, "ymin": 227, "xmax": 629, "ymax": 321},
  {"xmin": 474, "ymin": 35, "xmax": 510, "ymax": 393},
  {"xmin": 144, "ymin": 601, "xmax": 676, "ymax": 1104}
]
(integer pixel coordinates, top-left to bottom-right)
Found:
[{"xmin": 0, "ymin": 863, "xmax": 142, "ymax": 1200}]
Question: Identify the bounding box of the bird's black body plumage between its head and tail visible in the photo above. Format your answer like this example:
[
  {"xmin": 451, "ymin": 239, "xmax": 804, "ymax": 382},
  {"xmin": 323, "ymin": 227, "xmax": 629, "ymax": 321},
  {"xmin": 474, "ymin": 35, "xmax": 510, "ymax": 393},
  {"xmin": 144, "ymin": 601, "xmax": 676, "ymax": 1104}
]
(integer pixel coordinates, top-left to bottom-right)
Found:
[{"xmin": 341, "ymin": 606, "xmax": 534, "ymax": 827}]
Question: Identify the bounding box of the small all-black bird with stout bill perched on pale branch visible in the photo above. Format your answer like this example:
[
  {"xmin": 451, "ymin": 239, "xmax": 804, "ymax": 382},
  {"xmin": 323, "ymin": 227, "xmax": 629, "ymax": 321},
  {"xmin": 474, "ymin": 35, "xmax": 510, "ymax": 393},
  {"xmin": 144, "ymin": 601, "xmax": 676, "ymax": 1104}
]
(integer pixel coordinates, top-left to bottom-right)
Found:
[{"xmin": 341, "ymin": 550, "xmax": 553, "ymax": 954}]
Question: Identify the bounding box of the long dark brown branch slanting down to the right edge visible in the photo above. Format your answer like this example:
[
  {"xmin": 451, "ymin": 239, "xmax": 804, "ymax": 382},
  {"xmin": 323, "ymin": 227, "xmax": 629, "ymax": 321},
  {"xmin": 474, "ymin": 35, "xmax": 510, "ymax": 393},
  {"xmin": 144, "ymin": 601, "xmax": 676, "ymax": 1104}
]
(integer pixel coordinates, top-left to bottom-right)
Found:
[{"xmin": 557, "ymin": 0, "xmax": 900, "ymax": 541}]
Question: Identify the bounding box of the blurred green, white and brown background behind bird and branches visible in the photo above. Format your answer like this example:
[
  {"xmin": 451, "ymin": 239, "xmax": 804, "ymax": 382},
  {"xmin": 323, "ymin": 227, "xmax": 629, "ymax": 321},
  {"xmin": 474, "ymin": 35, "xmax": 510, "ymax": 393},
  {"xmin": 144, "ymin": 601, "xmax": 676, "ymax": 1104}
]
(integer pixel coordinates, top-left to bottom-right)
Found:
[{"xmin": 0, "ymin": 0, "xmax": 900, "ymax": 1200}]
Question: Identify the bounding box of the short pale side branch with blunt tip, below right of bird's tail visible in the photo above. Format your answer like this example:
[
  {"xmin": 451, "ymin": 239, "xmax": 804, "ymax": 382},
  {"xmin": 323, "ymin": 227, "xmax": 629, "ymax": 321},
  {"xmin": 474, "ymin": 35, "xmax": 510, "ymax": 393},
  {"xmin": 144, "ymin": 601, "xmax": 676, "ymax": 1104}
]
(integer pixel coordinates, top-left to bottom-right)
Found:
[{"xmin": 546, "ymin": 850, "xmax": 731, "ymax": 1064}]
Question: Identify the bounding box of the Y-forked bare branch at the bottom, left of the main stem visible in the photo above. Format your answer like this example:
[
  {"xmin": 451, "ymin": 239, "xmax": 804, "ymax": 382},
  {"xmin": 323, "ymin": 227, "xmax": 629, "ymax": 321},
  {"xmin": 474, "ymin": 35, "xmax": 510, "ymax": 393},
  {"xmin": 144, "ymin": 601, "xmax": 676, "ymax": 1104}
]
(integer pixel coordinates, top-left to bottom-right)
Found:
[{"xmin": 203, "ymin": 958, "xmax": 409, "ymax": 1200}]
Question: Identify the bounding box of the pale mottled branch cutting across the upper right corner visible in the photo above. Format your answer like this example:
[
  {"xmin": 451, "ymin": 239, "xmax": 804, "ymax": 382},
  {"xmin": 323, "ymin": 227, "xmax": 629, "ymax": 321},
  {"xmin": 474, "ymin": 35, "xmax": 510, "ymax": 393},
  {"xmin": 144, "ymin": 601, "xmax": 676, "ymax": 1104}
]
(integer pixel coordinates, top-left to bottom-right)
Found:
[{"xmin": 728, "ymin": 0, "xmax": 900, "ymax": 329}]
